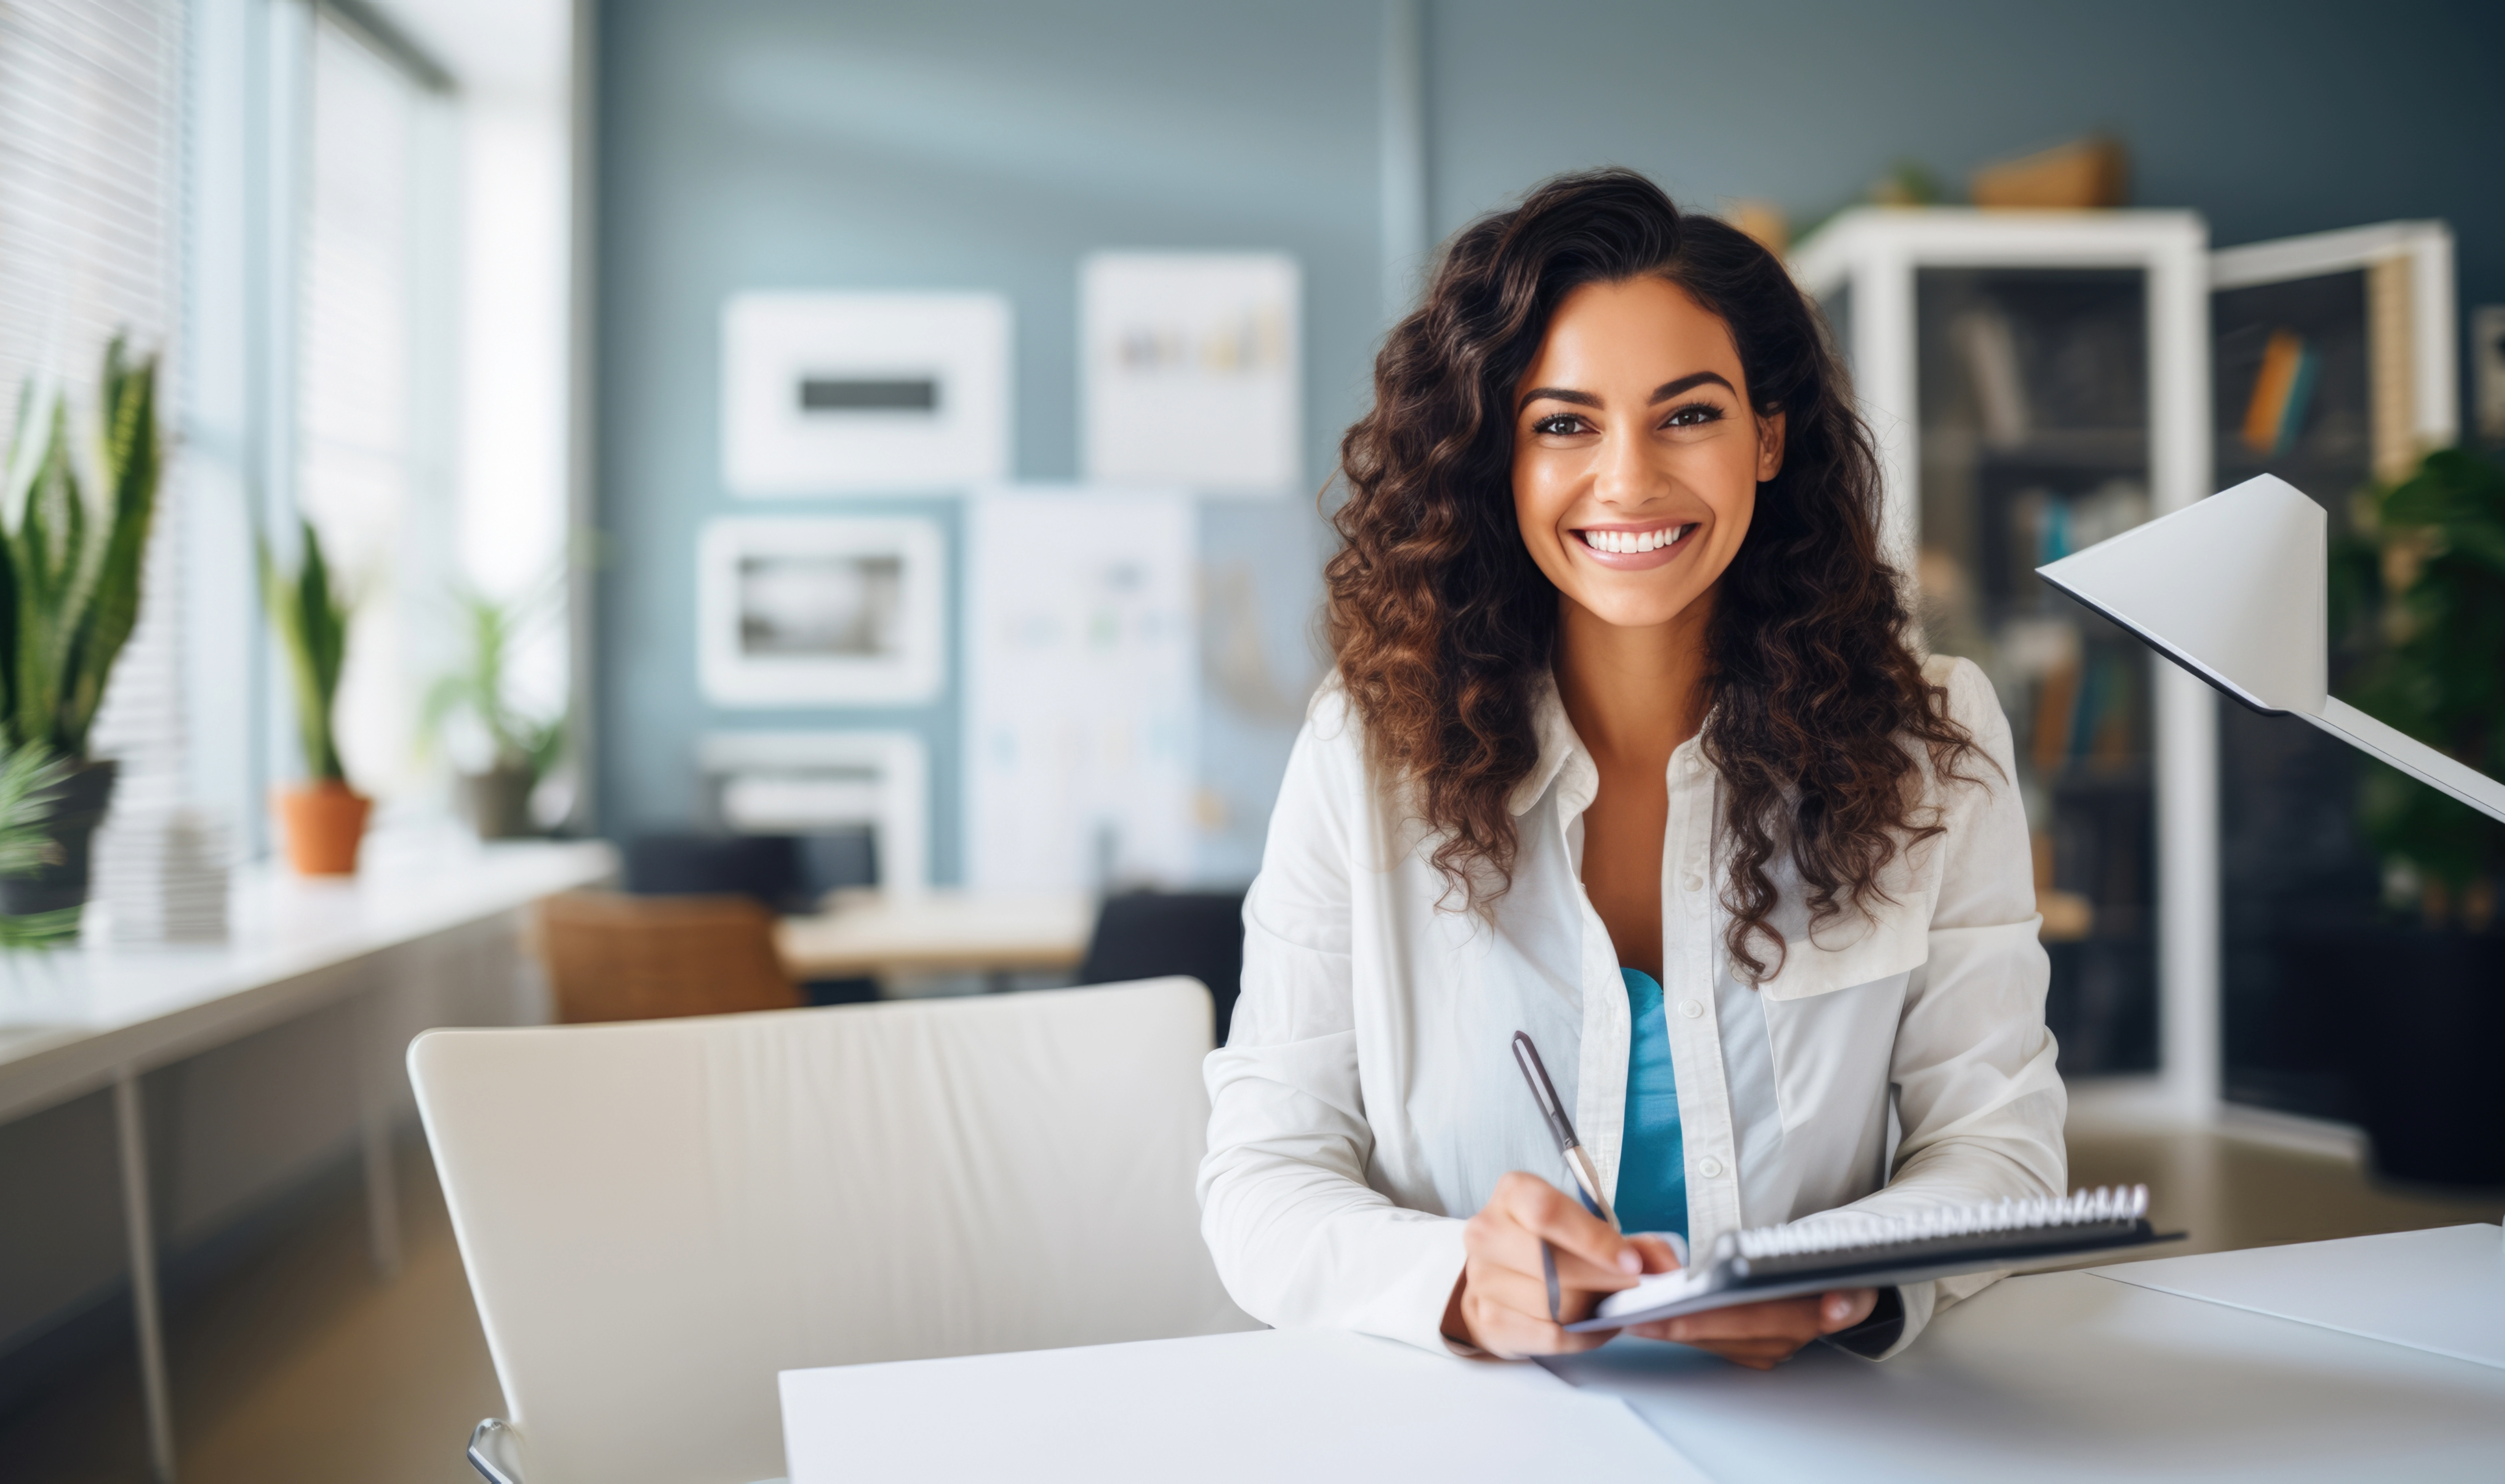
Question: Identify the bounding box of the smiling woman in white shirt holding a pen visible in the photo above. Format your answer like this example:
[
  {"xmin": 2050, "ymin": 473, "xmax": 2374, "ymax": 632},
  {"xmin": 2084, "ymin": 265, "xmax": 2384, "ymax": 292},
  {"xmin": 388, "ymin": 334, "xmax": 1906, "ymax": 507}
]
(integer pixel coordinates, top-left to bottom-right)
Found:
[{"xmin": 1200, "ymin": 170, "xmax": 2067, "ymax": 1367}]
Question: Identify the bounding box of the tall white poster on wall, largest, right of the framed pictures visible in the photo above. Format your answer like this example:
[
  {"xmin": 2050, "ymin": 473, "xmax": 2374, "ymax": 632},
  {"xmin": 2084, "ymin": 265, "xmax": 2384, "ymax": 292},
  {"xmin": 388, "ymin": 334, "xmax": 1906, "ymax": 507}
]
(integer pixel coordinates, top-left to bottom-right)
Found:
[{"xmin": 964, "ymin": 488, "xmax": 1200, "ymax": 891}]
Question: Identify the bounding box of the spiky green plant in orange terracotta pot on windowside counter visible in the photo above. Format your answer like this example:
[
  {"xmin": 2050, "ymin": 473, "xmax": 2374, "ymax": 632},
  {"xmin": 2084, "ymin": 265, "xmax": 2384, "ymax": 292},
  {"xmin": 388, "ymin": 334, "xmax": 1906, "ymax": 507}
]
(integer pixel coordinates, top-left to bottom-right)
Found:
[{"xmin": 260, "ymin": 521, "xmax": 373, "ymax": 876}]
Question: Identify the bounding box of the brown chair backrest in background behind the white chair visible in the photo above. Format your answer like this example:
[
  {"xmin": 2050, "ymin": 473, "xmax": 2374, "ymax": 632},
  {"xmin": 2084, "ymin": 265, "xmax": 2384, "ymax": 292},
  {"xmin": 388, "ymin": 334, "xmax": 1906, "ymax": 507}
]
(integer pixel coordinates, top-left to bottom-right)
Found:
[{"xmin": 539, "ymin": 891, "xmax": 802, "ymax": 1024}]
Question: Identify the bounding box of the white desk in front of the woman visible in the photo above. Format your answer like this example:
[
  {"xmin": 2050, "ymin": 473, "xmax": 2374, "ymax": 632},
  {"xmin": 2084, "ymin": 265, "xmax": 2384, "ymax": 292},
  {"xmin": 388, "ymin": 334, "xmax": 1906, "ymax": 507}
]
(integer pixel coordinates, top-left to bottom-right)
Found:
[{"xmin": 784, "ymin": 1226, "xmax": 2505, "ymax": 1484}]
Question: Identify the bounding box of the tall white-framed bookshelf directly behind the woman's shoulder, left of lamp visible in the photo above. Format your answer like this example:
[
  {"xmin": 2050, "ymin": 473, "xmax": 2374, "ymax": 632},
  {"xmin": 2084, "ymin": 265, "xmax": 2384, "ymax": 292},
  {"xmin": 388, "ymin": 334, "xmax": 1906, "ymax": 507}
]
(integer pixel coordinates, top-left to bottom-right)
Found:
[{"xmin": 1793, "ymin": 208, "xmax": 2219, "ymax": 1124}]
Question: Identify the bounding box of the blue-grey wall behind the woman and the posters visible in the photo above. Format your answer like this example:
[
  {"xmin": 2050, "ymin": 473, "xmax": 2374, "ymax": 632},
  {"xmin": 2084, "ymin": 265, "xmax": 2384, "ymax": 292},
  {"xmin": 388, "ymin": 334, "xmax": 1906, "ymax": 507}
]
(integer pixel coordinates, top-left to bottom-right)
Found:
[{"xmin": 598, "ymin": 0, "xmax": 2505, "ymax": 881}]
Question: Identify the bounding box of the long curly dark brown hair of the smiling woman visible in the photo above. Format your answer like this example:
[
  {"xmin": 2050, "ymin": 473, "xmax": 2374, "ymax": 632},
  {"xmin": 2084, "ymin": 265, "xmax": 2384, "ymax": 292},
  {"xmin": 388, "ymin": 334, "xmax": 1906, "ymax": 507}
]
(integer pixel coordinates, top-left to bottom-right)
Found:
[{"xmin": 1325, "ymin": 170, "xmax": 1974, "ymax": 981}]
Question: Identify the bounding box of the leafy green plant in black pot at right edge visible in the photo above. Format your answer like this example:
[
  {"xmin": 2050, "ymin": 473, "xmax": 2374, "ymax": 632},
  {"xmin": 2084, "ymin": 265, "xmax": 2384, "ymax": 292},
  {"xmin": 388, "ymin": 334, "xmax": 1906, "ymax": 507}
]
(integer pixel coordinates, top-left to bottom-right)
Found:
[{"xmin": 2332, "ymin": 448, "xmax": 2505, "ymax": 1186}]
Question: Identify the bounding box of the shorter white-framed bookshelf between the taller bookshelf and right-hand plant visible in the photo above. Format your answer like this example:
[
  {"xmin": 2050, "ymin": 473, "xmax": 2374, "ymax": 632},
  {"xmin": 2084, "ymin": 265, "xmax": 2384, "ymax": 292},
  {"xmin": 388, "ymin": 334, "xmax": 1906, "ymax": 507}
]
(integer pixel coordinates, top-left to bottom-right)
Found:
[{"xmin": 2209, "ymin": 223, "xmax": 2460, "ymax": 1124}]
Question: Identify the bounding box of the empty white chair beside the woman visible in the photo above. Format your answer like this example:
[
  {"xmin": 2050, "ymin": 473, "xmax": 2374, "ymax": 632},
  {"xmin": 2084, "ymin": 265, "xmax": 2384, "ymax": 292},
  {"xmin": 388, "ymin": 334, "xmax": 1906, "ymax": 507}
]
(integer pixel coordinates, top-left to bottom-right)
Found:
[{"xmin": 423, "ymin": 979, "xmax": 1258, "ymax": 1484}]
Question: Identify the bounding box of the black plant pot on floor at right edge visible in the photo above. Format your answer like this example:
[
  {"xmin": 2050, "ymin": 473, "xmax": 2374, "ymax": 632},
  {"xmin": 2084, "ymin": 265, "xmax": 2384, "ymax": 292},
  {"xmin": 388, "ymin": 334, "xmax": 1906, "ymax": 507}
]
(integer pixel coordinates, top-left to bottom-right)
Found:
[{"xmin": 2347, "ymin": 928, "xmax": 2505, "ymax": 1186}]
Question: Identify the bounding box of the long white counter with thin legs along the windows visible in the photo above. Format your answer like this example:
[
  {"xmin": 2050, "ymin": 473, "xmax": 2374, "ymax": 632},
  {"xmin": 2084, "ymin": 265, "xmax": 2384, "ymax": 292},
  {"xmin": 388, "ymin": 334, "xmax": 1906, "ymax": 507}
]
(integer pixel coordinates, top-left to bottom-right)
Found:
[{"xmin": 0, "ymin": 836, "xmax": 616, "ymax": 1479}]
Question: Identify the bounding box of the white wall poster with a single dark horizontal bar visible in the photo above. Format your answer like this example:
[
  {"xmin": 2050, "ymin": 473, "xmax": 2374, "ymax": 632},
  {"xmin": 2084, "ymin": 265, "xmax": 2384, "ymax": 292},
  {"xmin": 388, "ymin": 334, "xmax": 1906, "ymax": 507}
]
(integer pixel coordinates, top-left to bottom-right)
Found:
[{"xmin": 721, "ymin": 293, "xmax": 1009, "ymax": 495}]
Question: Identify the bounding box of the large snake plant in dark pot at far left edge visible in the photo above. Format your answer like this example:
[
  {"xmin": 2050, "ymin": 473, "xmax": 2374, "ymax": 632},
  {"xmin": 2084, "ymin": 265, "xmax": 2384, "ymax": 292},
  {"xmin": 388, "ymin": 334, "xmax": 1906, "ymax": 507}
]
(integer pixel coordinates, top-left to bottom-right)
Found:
[{"xmin": 0, "ymin": 336, "xmax": 163, "ymax": 916}]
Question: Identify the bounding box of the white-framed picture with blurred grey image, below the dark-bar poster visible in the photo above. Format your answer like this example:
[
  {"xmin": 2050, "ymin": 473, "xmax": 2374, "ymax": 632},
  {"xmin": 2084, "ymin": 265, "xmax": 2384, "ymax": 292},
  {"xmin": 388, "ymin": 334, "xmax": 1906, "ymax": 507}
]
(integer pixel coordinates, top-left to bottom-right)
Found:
[{"xmin": 697, "ymin": 516, "xmax": 947, "ymax": 706}]
